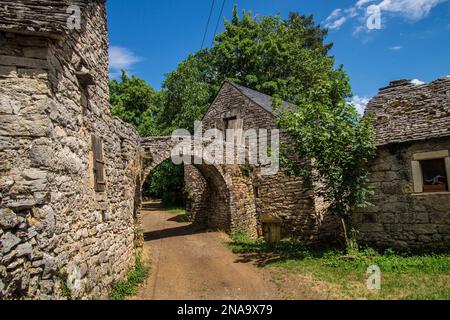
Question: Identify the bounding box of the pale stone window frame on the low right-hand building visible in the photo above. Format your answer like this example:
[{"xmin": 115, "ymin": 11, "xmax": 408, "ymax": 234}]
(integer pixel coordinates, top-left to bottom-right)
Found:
[{"xmin": 411, "ymin": 150, "xmax": 450, "ymax": 194}]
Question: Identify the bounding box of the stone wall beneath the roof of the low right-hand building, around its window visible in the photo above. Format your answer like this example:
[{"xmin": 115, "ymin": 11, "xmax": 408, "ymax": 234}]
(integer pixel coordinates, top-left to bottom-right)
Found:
[{"xmin": 354, "ymin": 138, "xmax": 450, "ymax": 250}]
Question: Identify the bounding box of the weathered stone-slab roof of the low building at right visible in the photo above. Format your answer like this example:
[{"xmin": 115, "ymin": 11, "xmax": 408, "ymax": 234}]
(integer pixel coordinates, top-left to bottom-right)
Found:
[{"xmin": 366, "ymin": 77, "xmax": 450, "ymax": 146}]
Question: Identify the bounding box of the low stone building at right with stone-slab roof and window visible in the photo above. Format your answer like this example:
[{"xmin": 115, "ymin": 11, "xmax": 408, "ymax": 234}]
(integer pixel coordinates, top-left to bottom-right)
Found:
[{"xmin": 355, "ymin": 77, "xmax": 450, "ymax": 250}]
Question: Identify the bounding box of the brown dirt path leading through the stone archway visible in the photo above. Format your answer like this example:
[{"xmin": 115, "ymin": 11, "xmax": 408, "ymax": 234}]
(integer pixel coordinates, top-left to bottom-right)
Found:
[{"xmin": 137, "ymin": 204, "xmax": 279, "ymax": 300}]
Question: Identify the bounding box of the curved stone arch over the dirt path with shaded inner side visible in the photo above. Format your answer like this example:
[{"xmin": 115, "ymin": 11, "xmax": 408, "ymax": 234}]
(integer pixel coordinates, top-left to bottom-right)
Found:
[{"xmin": 140, "ymin": 137, "xmax": 234, "ymax": 232}]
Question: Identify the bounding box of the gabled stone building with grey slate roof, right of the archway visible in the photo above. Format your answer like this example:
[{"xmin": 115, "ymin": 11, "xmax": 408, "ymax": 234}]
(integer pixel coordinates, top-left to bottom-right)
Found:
[{"xmin": 185, "ymin": 82, "xmax": 340, "ymax": 243}]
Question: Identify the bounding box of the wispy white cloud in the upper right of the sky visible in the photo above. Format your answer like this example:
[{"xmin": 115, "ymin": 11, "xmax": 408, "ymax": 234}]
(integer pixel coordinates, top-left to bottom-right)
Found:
[{"xmin": 324, "ymin": 0, "xmax": 449, "ymax": 35}]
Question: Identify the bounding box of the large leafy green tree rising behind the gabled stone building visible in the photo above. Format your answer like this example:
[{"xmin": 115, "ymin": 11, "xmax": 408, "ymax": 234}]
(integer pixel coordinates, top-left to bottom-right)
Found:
[{"xmin": 158, "ymin": 7, "xmax": 332, "ymax": 134}]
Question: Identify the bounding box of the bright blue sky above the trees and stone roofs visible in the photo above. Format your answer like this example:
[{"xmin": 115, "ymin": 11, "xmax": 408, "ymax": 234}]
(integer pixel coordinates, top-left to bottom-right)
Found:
[{"xmin": 107, "ymin": 0, "xmax": 450, "ymax": 113}]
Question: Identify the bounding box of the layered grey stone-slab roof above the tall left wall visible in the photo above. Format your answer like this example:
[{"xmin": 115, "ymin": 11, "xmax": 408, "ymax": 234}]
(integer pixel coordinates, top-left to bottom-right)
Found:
[{"xmin": 0, "ymin": 0, "xmax": 89, "ymax": 38}]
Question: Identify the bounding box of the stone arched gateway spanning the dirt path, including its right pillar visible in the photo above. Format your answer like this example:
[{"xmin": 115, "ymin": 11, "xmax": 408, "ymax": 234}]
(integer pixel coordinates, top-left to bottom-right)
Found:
[{"xmin": 136, "ymin": 137, "xmax": 257, "ymax": 235}]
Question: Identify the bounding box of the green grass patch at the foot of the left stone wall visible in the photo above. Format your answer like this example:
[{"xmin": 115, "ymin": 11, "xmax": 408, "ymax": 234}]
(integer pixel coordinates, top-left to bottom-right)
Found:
[{"xmin": 109, "ymin": 255, "xmax": 150, "ymax": 300}]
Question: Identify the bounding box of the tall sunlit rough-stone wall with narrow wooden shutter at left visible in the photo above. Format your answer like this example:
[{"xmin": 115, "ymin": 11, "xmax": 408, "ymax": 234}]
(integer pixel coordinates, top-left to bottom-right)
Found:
[{"xmin": 0, "ymin": 0, "xmax": 140, "ymax": 299}]
